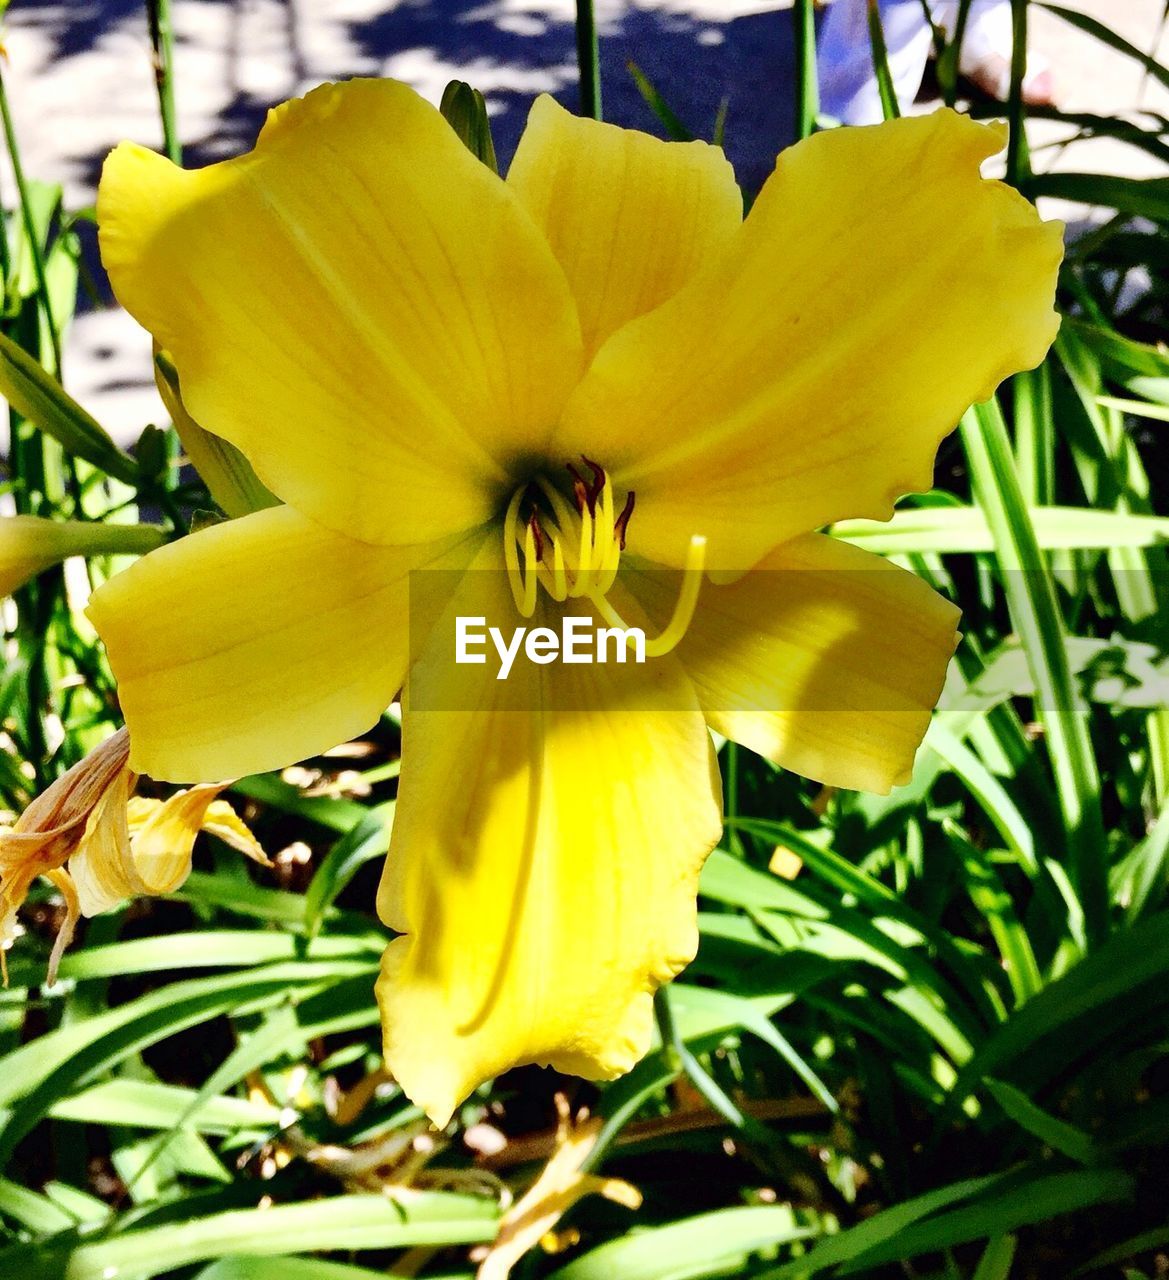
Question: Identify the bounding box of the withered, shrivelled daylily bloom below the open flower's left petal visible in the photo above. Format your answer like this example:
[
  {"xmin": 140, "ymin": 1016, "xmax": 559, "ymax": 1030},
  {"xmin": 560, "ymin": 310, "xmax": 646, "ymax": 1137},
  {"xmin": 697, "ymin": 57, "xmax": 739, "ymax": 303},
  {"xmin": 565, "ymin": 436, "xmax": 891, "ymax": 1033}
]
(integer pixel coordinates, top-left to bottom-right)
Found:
[{"xmin": 0, "ymin": 728, "xmax": 268, "ymax": 982}]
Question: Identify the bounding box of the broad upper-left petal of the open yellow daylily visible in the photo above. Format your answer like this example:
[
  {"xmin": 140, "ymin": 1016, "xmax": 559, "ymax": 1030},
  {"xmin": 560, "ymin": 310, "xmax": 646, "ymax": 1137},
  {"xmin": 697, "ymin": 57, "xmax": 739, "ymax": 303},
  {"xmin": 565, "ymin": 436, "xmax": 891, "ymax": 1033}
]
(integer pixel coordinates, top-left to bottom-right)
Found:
[{"xmin": 97, "ymin": 81, "xmax": 581, "ymax": 544}]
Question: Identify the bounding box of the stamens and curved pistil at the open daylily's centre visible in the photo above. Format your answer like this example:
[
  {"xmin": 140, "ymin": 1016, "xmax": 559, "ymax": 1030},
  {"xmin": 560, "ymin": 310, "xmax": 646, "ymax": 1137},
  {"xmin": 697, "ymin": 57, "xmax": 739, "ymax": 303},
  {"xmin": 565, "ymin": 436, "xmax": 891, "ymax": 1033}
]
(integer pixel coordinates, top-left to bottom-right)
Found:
[{"xmin": 503, "ymin": 458, "xmax": 707, "ymax": 657}]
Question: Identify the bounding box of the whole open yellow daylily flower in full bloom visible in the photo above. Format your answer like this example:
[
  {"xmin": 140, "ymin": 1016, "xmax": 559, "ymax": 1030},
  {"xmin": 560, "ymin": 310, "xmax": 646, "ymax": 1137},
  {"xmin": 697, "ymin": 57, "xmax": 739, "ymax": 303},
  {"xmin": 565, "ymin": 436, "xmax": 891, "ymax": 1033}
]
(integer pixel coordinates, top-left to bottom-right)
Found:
[{"xmin": 91, "ymin": 81, "xmax": 1061, "ymax": 1124}]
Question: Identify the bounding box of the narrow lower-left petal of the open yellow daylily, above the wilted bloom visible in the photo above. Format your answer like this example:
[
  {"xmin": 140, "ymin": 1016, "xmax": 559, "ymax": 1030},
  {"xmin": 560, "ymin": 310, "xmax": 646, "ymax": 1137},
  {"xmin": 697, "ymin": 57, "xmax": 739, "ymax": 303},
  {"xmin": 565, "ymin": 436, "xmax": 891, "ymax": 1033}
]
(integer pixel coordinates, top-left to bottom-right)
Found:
[{"xmin": 88, "ymin": 507, "xmax": 478, "ymax": 782}]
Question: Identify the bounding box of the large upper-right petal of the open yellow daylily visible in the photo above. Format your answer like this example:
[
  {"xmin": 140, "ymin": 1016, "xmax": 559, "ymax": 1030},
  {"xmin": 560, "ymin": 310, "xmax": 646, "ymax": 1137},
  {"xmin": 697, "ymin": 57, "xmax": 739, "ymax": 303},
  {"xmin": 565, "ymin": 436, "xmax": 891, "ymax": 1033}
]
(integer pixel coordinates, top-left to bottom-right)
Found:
[{"xmin": 558, "ymin": 110, "xmax": 1061, "ymax": 570}]
